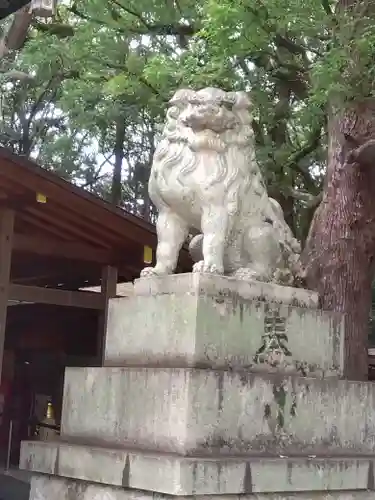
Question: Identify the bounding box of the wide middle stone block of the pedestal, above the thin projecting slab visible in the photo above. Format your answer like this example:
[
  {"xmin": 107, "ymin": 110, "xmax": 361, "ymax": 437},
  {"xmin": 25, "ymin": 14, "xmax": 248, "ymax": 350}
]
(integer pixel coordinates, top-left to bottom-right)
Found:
[{"xmin": 62, "ymin": 368, "xmax": 375, "ymax": 455}]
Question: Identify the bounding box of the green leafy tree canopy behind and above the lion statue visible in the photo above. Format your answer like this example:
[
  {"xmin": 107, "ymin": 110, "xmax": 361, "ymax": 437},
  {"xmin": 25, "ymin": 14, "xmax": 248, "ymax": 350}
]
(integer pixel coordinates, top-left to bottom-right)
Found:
[{"xmin": 0, "ymin": 0, "xmax": 375, "ymax": 229}]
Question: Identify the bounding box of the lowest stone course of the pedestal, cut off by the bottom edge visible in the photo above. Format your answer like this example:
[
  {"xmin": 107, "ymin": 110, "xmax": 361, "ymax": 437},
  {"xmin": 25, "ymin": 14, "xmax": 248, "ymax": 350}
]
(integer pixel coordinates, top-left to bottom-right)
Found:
[{"xmin": 30, "ymin": 476, "xmax": 375, "ymax": 500}]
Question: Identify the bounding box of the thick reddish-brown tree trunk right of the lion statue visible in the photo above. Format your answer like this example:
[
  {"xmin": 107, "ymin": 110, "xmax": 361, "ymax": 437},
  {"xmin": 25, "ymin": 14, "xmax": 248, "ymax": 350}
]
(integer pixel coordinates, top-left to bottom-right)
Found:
[{"xmin": 303, "ymin": 103, "xmax": 375, "ymax": 380}]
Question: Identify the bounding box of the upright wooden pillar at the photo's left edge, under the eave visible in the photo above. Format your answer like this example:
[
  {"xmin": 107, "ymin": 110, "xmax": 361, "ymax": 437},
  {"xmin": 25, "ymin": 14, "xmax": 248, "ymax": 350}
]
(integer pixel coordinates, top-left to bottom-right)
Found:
[{"xmin": 0, "ymin": 208, "xmax": 14, "ymax": 382}]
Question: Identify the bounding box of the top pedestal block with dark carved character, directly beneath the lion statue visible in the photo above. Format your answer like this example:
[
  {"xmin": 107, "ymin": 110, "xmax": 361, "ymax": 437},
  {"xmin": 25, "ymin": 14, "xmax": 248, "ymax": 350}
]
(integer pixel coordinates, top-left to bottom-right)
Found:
[{"xmin": 105, "ymin": 274, "xmax": 343, "ymax": 378}]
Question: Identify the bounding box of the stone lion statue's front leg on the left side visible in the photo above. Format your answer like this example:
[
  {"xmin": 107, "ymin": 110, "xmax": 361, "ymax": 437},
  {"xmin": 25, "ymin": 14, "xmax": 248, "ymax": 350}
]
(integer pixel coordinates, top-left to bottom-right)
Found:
[{"xmin": 141, "ymin": 209, "xmax": 188, "ymax": 277}]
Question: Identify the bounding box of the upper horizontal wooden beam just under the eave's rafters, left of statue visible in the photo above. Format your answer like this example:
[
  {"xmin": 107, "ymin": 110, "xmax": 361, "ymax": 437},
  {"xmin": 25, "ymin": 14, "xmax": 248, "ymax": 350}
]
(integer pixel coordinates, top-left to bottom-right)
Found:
[{"xmin": 13, "ymin": 234, "xmax": 111, "ymax": 264}]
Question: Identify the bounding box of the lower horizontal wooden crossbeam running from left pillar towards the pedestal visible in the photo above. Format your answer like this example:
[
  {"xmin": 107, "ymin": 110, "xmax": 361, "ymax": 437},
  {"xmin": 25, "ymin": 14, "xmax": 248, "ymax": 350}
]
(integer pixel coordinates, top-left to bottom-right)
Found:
[{"xmin": 8, "ymin": 283, "xmax": 105, "ymax": 310}]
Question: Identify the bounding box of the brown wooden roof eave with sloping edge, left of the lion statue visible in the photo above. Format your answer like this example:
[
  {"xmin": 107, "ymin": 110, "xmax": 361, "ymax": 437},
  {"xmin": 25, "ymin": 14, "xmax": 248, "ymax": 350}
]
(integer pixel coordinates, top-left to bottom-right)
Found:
[{"xmin": 0, "ymin": 148, "xmax": 191, "ymax": 286}]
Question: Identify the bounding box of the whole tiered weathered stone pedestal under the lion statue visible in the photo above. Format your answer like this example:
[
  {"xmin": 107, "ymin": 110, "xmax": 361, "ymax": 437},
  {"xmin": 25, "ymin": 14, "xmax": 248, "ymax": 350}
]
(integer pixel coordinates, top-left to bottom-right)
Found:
[{"xmin": 20, "ymin": 274, "xmax": 375, "ymax": 500}]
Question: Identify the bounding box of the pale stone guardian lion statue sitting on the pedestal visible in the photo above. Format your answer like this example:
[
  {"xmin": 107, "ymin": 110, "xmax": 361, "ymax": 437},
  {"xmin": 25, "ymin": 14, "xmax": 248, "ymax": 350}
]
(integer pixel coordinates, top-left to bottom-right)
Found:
[{"xmin": 141, "ymin": 88, "xmax": 300, "ymax": 284}]
